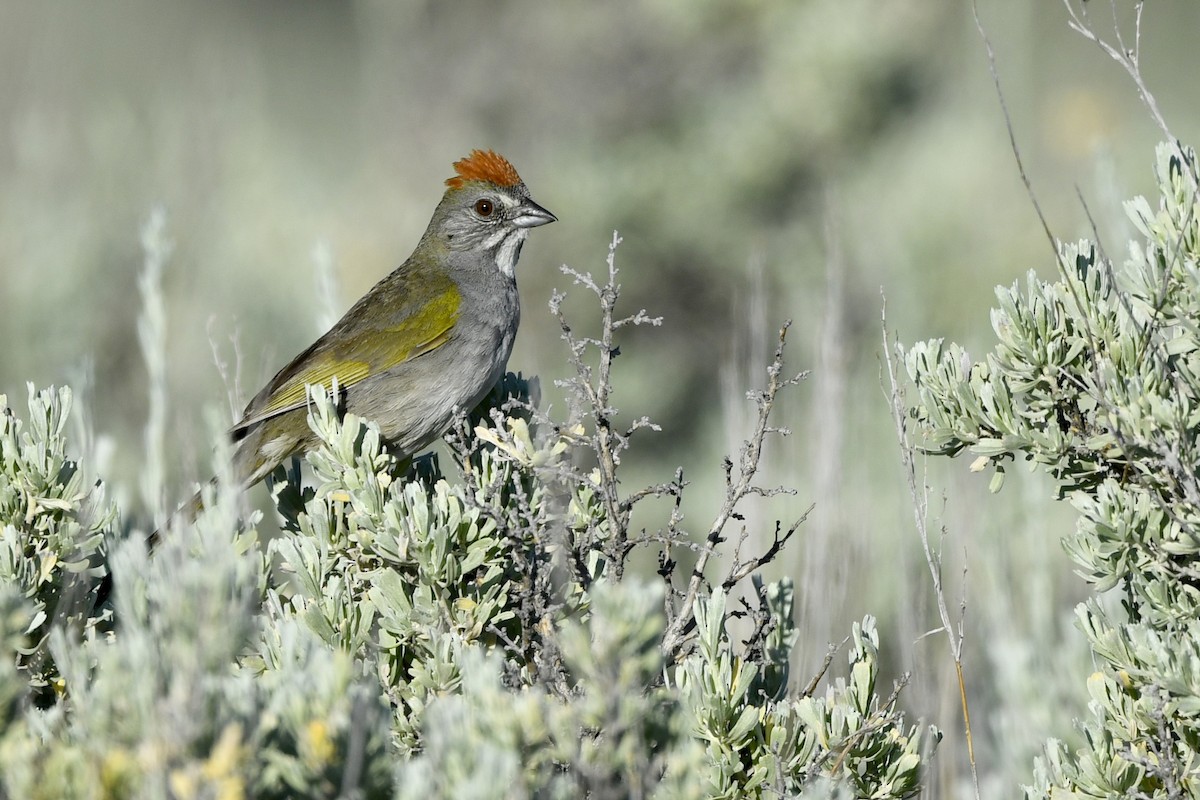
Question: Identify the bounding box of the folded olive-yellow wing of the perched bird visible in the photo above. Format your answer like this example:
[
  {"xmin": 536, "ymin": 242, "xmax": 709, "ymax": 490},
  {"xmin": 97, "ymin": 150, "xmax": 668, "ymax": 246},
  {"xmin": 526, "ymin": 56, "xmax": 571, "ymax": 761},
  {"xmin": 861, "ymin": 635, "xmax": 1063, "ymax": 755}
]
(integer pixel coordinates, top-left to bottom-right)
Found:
[{"xmin": 230, "ymin": 279, "xmax": 461, "ymax": 440}]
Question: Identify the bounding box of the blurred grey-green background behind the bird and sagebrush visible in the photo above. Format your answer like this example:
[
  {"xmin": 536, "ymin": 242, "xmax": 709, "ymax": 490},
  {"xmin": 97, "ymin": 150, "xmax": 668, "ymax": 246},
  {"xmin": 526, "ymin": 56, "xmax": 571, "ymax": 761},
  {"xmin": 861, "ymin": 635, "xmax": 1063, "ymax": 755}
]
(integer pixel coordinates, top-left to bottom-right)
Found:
[{"xmin": 0, "ymin": 0, "xmax": 1200, "ymax": 798}]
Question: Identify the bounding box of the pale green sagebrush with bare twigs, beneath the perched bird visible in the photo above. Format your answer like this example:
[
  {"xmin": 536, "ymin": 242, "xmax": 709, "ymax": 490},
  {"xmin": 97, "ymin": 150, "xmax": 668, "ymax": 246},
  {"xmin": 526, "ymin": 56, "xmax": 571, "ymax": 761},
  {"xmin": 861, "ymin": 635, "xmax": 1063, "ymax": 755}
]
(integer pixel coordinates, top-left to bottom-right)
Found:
[{"xmin": 0, "ymin": 241, "xmax": 937, "ymax": 799}]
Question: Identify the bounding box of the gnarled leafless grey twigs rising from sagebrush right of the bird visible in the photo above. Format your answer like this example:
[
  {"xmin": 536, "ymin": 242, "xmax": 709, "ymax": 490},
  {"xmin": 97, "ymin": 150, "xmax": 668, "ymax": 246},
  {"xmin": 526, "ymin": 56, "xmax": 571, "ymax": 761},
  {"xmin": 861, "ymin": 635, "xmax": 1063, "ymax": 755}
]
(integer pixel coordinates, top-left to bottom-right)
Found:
[{"xmin": 501, "ymin": 234, "xmax": 811, "ymax": 676}]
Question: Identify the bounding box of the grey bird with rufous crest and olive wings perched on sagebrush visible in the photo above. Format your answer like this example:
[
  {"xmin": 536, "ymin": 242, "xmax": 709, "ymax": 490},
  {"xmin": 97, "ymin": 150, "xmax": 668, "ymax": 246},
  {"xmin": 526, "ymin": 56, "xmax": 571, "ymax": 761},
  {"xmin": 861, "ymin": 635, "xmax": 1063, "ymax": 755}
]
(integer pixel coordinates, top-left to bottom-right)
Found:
[{"xmin": 225, "ymin": 150, "xmax": 556, "ymax": 496}]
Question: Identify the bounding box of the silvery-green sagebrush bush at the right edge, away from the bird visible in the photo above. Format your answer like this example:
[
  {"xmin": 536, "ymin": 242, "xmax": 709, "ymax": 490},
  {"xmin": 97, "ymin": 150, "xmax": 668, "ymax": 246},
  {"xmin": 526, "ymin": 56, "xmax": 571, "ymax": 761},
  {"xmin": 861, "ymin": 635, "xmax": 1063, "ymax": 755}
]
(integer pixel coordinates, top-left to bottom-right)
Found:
[{"xmin": 905, "ymin": 144, "xmax": 1200, "ymax": 798}]
